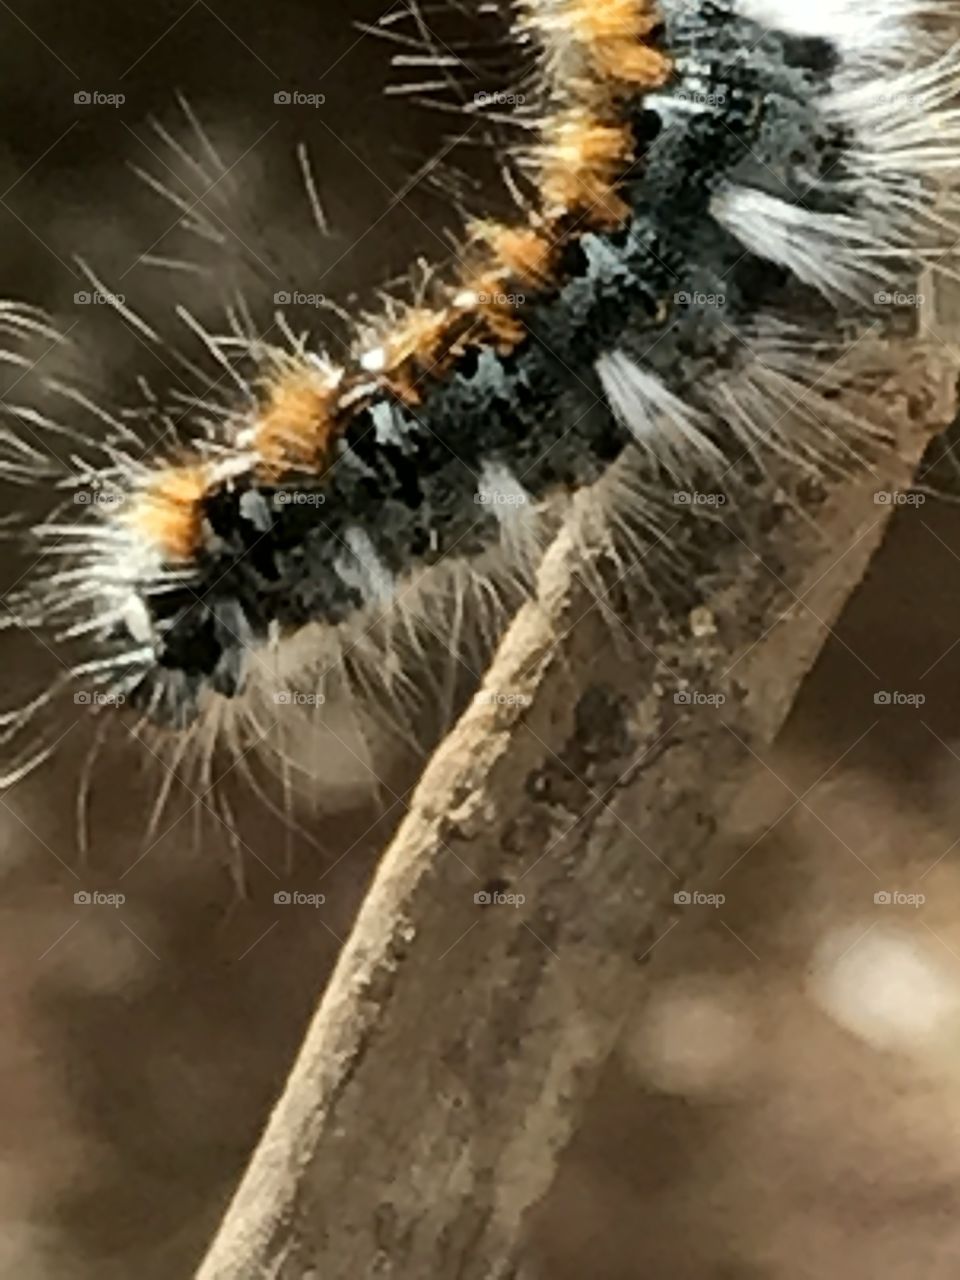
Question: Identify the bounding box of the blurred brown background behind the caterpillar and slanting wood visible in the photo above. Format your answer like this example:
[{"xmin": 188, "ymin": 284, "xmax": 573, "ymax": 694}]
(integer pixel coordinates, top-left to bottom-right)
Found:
[{"xmin": 0, "ymin": 0, "xmax": 960, "ymax": 1280}]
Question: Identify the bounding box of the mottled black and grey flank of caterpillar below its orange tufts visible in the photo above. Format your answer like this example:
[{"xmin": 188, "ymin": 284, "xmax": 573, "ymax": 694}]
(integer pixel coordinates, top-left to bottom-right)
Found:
[{"xmin": 134, "ymin": 4, "xmax": 841, "ymax": 721}]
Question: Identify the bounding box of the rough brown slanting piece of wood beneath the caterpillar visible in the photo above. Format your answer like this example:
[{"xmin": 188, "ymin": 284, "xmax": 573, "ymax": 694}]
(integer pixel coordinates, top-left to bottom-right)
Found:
[{"xmin": 198, "ymin": 330, "xmax": 954, "ymax": 1280}]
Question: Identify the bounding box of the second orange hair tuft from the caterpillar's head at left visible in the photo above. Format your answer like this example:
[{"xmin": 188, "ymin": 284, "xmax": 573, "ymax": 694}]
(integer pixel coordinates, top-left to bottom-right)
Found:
[{"xmin": 252, "ymin": 364, "xmax": 340, "ymax": 479}]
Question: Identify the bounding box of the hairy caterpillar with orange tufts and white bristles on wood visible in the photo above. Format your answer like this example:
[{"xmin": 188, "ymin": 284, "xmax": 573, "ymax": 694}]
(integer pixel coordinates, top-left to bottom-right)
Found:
[{"xmin": 0, "ymin": 0, "xmax": 960, "ymax": 855}]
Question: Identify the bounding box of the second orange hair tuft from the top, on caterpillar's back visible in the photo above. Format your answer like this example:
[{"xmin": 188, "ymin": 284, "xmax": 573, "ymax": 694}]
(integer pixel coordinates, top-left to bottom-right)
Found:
[{"xmin": 534, "ymin": 108, "xmax": 634, "ymax": 227}]
